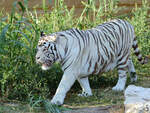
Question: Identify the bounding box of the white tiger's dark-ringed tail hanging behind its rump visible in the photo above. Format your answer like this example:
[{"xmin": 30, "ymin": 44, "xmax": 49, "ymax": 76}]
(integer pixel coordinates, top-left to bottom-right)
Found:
[{"xmin": 132, "ymin": 37, "xmax": 149, "ymax": 65}]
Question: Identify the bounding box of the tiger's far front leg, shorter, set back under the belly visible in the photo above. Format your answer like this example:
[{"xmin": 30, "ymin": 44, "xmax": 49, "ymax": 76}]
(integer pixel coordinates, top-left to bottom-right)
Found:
[{"xmin": 78, "ymin": 77, "xmax": 92, "ymax": 97}]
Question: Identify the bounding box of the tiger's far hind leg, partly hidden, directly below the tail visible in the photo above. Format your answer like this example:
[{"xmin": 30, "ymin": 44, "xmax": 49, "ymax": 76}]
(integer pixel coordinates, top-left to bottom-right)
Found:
[{"xmin": 128, "ymin": 58, "xmax": 137, "ymax": 82}]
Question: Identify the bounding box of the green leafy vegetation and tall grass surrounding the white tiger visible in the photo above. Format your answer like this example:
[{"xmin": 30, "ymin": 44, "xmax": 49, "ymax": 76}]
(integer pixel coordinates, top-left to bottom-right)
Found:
[{"xmin": 0, "ymin": 0, "xmax": 150, "ymax": 112}]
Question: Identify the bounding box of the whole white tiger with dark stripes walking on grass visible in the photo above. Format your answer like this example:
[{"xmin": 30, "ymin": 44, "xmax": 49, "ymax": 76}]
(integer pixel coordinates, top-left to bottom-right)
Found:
[{"xmin": 36, "ymin": 19, "xmax": 147, "ymax": 105}]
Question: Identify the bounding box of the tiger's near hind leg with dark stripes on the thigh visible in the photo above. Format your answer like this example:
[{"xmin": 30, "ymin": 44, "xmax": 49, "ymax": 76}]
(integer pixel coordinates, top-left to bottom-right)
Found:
[{"xmin": 112, "ymin": 56, "xmax": 128, "ymax": 91}]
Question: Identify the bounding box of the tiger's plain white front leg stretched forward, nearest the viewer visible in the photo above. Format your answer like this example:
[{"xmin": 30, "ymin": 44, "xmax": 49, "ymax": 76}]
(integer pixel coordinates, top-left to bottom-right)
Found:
[{"xmin": 51, "ymin": 71, "xmax": 76, "ymax": 105}]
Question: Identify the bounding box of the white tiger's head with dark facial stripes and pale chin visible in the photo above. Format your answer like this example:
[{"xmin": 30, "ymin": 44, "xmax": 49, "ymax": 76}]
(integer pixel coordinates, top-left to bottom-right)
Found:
[{"xmin": 36, "ymin": 32, "xmax": 57, "ymax": 70}]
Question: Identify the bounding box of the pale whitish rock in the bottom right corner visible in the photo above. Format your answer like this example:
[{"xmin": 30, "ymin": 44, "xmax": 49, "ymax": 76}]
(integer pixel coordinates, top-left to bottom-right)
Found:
[{"xmin": 124, "ymin": 85, "xmax": 150, "ymax": 113}]
